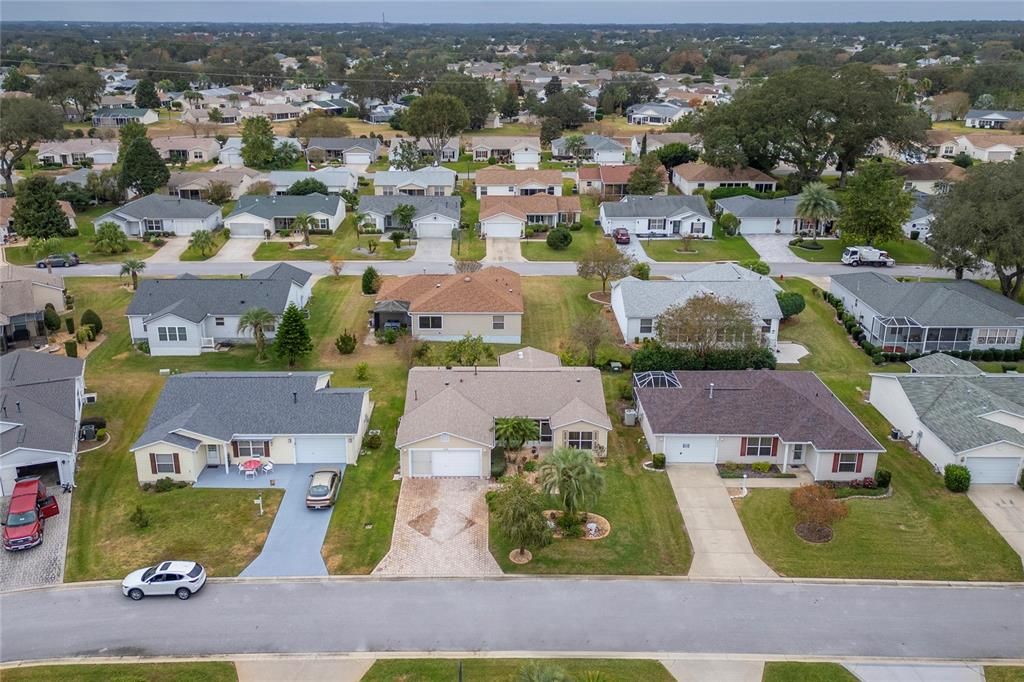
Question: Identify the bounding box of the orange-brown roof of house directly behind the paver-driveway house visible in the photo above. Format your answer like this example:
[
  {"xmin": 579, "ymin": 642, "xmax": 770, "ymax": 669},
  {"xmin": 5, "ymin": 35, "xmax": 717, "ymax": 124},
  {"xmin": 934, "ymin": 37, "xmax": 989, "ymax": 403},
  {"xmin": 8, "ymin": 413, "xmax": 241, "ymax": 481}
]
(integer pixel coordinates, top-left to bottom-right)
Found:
[{"xmin": 377, "ymin": 267, "xmax": 523, "ymax": 313}]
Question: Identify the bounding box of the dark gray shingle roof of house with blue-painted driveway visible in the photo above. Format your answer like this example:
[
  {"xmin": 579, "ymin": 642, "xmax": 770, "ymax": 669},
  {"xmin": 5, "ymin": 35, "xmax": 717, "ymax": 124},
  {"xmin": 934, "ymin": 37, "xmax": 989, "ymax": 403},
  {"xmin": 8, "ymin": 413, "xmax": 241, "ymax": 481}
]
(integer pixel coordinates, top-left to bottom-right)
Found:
[{"xmin": 131, "ymin": 372, "xmax": 370, "ymax": 450}]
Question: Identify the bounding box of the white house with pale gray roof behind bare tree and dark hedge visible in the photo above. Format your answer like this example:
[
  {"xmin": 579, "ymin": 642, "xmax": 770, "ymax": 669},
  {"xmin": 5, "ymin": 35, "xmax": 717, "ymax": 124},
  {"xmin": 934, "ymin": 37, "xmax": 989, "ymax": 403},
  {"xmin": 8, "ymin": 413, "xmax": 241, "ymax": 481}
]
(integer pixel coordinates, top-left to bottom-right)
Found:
[{"xmin": 611, "ymin": 270, "xmax": 782, "ymax": 348}]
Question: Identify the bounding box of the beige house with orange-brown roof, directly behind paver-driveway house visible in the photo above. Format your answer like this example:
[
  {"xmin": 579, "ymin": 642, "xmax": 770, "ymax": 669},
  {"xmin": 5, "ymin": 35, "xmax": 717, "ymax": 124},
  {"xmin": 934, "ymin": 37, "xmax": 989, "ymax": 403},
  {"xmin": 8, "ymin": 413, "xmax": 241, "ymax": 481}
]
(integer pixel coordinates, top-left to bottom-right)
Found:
[{"xmin": 370, "ymin": 267, "xmax": 524, "ymax": 343}]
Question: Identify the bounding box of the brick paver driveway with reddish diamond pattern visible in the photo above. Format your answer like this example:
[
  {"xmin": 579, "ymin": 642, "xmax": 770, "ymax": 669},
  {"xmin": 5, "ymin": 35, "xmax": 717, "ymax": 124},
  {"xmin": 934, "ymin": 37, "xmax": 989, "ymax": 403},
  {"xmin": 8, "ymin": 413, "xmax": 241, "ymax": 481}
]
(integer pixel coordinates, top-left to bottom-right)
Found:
[{"xmin": 374, "ymin": 478, "xmax": 502, "ymax": 578}]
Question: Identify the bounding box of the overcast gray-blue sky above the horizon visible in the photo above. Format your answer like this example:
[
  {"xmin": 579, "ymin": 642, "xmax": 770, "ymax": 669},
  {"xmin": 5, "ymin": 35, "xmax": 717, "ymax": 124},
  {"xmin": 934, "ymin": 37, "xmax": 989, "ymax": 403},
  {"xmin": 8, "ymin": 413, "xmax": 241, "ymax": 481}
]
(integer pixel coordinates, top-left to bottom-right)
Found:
[{"xmin": 0, "ymin": 0, "xmax": 1024, "ymax": 24}]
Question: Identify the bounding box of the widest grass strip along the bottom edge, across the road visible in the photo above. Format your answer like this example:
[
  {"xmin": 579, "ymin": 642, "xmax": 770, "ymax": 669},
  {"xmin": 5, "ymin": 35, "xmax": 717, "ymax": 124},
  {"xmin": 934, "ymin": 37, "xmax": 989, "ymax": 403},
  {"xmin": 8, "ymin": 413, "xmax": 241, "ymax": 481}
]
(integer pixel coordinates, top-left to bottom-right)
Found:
[{"xmin": 362, "ymin": 658, "xmax": 675, "ymax": 682}]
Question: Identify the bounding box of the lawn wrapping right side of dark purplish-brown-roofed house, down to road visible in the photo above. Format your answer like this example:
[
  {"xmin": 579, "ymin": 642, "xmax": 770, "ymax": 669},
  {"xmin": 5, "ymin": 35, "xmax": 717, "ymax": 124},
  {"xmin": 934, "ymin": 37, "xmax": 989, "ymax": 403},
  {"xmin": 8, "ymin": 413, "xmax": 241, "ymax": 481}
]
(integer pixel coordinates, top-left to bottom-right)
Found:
[{"xmin": 737, "ymin": 280, "xmax": 1024, "ymax": 581}]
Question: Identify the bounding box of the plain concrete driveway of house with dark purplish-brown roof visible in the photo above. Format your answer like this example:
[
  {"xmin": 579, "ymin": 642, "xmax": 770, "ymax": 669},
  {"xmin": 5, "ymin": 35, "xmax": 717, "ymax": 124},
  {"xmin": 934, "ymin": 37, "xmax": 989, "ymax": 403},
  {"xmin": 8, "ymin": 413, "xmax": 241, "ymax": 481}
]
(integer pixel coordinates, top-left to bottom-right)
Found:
[{"xmin": 668, "ymin": 464, "xmax": 775, "ymax": 578}]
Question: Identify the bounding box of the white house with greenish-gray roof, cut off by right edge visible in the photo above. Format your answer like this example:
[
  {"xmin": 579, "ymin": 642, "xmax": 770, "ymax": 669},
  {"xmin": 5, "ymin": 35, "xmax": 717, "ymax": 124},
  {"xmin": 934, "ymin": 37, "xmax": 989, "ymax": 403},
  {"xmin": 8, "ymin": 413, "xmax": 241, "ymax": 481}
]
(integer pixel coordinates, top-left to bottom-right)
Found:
[{"xmin": 870, "ymin": 353, "xmax": 1024, "ymax": 485}]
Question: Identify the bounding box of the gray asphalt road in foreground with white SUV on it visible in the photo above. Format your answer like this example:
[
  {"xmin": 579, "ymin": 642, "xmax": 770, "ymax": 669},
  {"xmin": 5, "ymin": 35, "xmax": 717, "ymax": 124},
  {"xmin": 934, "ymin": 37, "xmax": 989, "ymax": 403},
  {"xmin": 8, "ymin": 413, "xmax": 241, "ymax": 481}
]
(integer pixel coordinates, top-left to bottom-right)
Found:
[{"xmin": 0, "ymin": 579, "xmax": 1024, "ymax": 662}]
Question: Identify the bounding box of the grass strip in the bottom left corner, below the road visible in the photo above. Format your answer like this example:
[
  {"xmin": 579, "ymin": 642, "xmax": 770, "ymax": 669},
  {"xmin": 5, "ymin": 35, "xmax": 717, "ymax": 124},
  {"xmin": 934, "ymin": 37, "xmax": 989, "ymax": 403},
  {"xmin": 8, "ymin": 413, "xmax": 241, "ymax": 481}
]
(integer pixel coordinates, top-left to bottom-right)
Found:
[{"xmin": 3, "ymin": 660, "xmax": 239, "ymax": 682}]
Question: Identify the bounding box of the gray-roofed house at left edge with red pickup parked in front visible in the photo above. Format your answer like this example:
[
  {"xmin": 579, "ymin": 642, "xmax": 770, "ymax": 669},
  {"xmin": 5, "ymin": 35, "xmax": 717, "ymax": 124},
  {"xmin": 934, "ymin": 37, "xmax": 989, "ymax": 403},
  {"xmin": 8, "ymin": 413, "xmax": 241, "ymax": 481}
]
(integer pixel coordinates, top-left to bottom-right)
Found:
[{"xmin": 0, "ymin": 350, "xmax": 85, "ymax": 497}]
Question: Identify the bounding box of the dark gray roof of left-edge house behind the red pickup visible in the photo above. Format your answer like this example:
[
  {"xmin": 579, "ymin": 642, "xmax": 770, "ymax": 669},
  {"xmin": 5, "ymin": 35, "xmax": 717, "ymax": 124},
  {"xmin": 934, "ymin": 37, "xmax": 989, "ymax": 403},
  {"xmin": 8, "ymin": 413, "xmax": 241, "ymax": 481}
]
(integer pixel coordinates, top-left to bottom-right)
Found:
[{"xmin": 0, "ymin": 350, "xmax": 85, "ymax": 454}]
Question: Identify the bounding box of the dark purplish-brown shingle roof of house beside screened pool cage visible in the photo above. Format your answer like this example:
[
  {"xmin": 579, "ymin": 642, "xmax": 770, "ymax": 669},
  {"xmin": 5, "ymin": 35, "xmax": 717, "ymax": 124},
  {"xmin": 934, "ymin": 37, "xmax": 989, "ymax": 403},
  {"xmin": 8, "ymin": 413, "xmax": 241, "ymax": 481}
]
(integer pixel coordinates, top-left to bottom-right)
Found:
[{"xmin": 636, "ymin": 370, "xmax": 885, "ymax": 452}]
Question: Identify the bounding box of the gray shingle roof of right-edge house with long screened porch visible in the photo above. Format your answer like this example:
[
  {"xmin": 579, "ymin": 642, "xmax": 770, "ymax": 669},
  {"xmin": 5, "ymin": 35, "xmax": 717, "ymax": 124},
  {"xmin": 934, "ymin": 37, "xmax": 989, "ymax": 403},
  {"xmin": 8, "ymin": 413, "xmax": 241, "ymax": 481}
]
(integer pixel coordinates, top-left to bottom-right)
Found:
[{"xmin": 831, "ymin": 272, "xmax": 1024, "ymax": 327}]
